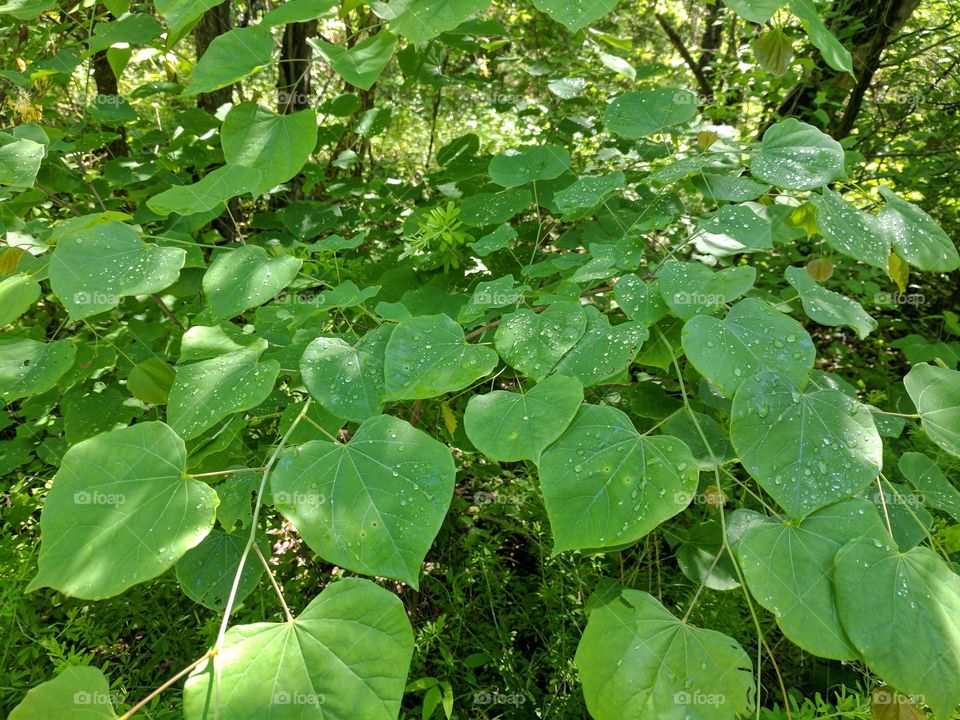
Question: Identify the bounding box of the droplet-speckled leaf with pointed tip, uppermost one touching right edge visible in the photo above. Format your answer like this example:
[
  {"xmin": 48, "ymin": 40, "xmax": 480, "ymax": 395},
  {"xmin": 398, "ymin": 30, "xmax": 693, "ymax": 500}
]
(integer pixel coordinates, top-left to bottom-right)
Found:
[{"xmin": 877, "ymin": 186, "xmax": 960, "ymax": 272}]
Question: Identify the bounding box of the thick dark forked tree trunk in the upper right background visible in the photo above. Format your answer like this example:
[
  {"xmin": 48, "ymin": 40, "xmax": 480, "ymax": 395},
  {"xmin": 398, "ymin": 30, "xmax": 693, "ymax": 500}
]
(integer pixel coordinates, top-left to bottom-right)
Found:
[{"xmin": 761, "ymin": 0, "xmax": 920, "ymax": 139}]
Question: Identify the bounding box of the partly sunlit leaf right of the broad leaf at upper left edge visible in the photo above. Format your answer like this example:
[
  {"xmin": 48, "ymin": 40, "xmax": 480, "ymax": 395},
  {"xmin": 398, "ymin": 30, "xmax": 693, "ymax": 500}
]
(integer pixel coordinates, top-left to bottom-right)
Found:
[{"xmin": 203, "ymin": 245, "xmax": 303, "ymax": 320}]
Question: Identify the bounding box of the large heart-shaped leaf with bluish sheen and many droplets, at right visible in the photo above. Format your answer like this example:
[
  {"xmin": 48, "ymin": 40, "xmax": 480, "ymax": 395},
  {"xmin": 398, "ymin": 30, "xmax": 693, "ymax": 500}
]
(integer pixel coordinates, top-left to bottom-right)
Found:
[{"xmin": 730, "ymin": 372, "xmax": 883, "ymax": 517}]
